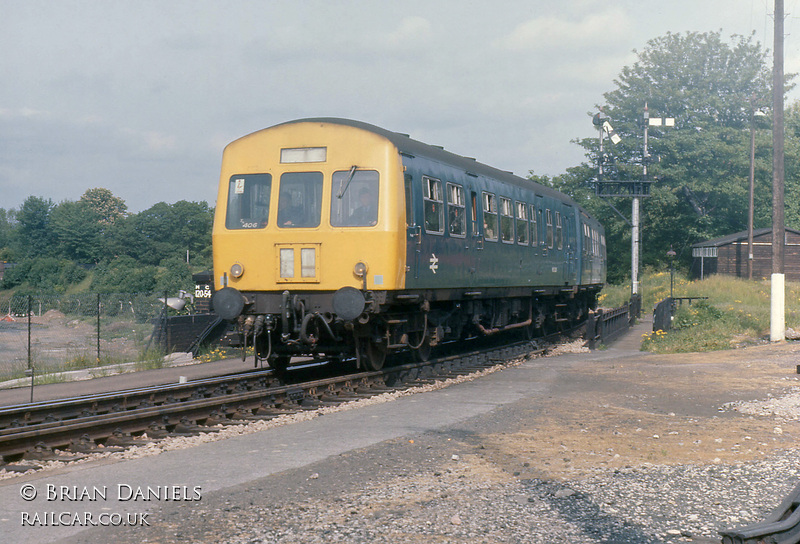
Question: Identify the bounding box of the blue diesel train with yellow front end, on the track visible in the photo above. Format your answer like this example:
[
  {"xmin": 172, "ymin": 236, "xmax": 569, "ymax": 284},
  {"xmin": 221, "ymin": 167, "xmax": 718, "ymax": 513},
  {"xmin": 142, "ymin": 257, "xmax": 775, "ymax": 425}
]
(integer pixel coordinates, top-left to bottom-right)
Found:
[{"xmin": 213, "ymin": 118, "xmax": 605, "ymax": 369}]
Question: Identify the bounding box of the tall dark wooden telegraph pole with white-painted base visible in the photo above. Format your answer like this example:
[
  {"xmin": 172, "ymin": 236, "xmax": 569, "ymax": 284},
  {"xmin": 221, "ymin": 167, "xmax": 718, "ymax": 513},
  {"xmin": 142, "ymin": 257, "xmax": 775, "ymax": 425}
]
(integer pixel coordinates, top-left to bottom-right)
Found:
[{"xmin": 769, "ymin": 0, "xmax": 786, "ymax": 342}]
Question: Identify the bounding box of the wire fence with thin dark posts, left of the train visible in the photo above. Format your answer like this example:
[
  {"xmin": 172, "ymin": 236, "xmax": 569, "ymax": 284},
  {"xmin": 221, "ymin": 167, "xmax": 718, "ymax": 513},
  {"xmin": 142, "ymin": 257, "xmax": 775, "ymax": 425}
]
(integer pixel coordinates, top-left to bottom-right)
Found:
[{"xmin": 0, "ymin": 293, "xmax": 187, "ymax": 381}]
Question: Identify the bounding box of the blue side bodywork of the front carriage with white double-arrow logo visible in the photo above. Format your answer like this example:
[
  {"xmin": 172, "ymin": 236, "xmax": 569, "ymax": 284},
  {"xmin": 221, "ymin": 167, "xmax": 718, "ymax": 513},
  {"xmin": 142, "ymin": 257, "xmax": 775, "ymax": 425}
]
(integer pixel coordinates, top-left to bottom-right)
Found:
[{"xmin": 403, "ymin": 155, "xmax": 602, "ymax": 289}]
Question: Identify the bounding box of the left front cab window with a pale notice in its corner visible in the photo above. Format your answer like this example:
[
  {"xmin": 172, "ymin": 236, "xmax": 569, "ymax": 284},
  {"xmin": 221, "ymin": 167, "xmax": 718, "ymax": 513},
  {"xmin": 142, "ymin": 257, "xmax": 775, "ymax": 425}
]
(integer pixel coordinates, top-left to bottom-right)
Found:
[{"xmin": 225, "ymin": 174, "xmax": 272, "ymax": 230}]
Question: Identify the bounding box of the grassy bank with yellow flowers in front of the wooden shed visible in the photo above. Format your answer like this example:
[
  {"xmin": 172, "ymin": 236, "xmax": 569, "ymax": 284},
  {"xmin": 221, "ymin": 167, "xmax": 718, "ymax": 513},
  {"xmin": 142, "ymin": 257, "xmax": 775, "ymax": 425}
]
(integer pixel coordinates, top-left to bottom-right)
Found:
[{"xmin": 600, "ymin": 271, "xmax": 800, "ymax": 353}]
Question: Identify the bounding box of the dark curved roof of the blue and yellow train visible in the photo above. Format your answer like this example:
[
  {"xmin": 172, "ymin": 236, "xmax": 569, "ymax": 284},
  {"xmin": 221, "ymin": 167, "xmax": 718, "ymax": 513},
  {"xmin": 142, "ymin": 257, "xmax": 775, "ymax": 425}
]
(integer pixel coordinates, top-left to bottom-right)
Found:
[{"xmin": 270, "ymin": 117, "xmax": 580, "ymax": 207}]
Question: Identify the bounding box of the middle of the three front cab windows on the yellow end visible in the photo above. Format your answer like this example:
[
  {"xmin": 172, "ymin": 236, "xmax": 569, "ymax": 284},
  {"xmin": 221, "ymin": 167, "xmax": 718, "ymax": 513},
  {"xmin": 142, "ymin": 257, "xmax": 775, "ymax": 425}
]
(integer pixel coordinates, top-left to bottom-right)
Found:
[{"xmin": 278, "ymin": 172, "xmax": 322, "ymax": 229}]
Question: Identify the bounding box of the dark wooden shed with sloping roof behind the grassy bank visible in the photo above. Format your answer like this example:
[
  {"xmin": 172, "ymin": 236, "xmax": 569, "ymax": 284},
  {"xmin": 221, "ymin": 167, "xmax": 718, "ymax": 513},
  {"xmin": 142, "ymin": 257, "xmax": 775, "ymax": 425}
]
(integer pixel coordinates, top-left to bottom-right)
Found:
[{"xmin": 691, "ymin": 228, "xmax": 800, "ymax": 281}]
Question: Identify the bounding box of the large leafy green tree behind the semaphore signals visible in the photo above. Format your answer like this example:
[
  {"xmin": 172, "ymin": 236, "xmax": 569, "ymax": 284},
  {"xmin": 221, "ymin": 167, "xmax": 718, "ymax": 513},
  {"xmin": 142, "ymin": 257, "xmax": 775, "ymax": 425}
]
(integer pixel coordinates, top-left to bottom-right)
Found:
[{"xmin": 559, "ymin": 32, "xmax": 800, "ymax": 279}]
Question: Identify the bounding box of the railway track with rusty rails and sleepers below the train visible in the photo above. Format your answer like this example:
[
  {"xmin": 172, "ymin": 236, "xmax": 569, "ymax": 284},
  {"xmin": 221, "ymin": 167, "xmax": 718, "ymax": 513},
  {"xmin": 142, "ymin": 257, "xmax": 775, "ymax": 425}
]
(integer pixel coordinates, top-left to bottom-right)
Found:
[{"xmin": 0, "ymin": 341, "xmax": 546, "ymax": 471}]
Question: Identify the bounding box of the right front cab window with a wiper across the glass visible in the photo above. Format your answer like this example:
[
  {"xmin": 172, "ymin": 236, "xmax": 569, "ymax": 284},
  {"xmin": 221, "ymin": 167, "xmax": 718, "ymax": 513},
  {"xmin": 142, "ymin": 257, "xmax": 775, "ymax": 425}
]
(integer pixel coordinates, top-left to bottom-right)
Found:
[{"xmin": 331, "ymin": 170, "xmax": 380, "ymax": 227}]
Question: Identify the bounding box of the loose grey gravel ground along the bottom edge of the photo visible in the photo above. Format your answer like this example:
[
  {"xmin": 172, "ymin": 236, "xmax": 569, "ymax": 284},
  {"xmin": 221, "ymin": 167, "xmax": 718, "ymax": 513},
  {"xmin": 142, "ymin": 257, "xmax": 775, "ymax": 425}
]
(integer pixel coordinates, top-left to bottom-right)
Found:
[{"xmin": 207, "ymin": 452, "xmax": 800, "ymax": 544}]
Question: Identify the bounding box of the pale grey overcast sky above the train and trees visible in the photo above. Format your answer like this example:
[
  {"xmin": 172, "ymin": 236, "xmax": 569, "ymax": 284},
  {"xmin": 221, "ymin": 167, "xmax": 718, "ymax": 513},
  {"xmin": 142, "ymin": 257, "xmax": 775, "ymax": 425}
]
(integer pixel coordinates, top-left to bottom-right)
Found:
[{"xmin": 0, "ymin": 0, "xmax": 800, "ymax": 212}]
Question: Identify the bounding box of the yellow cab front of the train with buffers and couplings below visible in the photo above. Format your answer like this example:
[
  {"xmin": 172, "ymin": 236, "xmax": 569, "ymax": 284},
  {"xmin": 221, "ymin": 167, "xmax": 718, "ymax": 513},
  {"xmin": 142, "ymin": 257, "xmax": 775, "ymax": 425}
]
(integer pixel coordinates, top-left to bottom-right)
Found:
[{"xmin": 212, "ymin": 120, "xmax": 406, "ymax": 366}]
